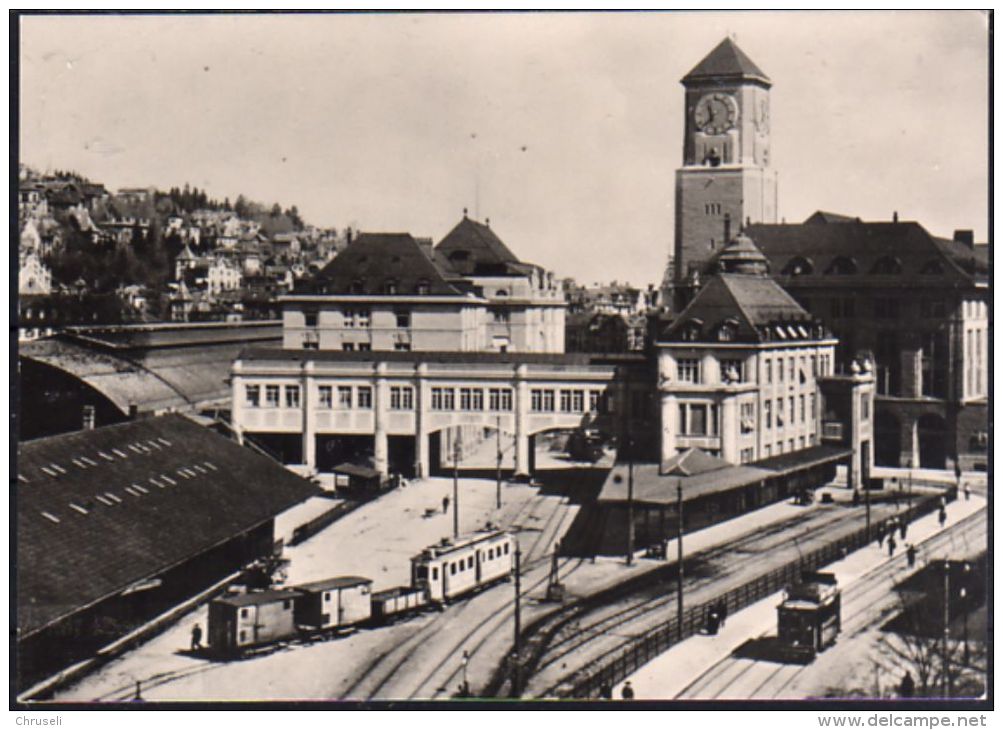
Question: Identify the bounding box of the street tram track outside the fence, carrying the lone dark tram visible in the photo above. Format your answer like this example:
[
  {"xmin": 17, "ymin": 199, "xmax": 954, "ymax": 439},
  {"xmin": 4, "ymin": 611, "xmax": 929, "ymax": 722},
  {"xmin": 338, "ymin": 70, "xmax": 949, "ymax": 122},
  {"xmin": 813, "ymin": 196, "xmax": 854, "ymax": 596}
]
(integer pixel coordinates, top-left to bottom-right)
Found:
[{"xmin": 675, "ymin": 508, "xmax": 989, "ymax": 700}]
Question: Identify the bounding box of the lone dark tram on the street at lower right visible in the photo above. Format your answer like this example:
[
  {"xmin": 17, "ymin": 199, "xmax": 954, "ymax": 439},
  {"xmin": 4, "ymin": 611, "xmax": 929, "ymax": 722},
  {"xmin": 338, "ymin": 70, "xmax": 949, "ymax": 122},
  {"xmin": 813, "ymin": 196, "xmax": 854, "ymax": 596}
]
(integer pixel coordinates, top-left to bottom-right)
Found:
[{"xmin": 776, "ymin": 573, "xmax": 841, "ymax": 662}]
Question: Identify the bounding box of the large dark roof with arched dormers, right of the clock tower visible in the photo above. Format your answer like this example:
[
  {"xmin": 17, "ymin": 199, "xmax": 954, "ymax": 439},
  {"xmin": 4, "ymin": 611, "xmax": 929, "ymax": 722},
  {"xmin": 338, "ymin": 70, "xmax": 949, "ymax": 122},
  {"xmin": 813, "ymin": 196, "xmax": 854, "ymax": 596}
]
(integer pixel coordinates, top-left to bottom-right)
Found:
[{"xmin": 745, "ymin": 214, "xmax": 988, "ymax": 286}]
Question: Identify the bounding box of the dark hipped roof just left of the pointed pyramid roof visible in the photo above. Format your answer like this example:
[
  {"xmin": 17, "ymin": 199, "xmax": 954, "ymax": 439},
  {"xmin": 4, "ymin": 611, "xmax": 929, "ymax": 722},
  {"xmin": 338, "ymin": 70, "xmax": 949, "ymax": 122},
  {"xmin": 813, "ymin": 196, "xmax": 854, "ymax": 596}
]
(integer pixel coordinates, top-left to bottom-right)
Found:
[{"xmin": 312, "ymin": 234, "xmax": 461, "ymax": 296}]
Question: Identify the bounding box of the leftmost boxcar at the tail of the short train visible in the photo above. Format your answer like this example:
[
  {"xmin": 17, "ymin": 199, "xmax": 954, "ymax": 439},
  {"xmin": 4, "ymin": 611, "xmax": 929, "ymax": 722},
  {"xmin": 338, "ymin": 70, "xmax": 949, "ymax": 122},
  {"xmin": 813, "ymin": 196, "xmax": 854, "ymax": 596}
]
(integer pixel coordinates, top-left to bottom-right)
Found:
[{"xmin": 209, "ymin": 589, "xmax": 300, "ymax": 655}]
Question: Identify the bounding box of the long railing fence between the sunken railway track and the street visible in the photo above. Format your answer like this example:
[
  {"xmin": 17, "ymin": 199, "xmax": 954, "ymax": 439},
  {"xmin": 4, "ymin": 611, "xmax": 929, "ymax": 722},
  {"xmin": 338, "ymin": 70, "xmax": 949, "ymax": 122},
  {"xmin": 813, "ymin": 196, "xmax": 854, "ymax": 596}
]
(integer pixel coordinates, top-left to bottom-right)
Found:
[{"xmin": 557, "ymin": 486, "xmax": 958, "ymax": 698}]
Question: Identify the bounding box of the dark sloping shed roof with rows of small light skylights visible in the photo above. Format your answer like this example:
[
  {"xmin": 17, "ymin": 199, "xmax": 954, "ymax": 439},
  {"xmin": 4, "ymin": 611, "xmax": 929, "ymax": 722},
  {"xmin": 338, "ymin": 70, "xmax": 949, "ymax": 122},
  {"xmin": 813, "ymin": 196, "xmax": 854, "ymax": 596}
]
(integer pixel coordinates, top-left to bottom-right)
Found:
[{"xmin": 16, "ymin": 414, "xmax": 317, "ymax": 635}]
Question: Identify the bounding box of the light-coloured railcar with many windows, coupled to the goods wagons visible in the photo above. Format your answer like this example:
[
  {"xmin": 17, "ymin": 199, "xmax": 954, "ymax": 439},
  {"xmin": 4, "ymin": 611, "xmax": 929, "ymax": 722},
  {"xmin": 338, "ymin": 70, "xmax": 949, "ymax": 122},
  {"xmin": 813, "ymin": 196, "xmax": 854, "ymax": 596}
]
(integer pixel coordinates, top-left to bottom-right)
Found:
[{"xmin": 411, "ymin": 529, "xmax": 515, "ymax": 603}]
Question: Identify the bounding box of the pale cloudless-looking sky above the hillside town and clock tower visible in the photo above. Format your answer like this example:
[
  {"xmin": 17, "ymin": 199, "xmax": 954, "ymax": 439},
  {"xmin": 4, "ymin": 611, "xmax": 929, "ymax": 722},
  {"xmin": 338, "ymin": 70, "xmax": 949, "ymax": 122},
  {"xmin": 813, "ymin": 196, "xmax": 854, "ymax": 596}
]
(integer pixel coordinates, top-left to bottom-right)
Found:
[{"xmin": 19, "ymin": 11, "xmax": 990, "ymax": 285}]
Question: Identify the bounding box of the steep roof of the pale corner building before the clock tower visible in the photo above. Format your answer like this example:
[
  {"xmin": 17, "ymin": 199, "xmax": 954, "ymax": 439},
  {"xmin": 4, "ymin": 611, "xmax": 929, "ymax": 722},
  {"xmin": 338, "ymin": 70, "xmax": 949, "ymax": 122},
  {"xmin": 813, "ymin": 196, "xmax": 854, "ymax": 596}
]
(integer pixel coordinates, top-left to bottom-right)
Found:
[{"xmin": 661, "ymin": 274, "xmax": 812, "ymax": 342}]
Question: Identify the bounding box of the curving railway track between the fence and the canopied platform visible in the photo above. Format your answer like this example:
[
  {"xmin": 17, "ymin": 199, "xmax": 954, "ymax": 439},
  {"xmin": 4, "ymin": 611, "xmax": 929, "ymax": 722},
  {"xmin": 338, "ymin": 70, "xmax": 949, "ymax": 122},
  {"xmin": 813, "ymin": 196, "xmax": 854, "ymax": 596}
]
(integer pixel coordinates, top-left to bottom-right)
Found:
[{"xmin": 526, "ymin": 507, "xmax": 902, "ymax": 696}]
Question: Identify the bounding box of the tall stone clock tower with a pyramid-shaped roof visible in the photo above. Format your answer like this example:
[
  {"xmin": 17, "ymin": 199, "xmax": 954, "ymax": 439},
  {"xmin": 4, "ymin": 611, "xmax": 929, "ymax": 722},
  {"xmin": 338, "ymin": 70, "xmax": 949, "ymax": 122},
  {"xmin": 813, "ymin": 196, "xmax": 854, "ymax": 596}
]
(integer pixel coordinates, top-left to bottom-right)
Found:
[{"xmin": 667, "ymin": 38, "xmax": 776, "ymax": 307}]
